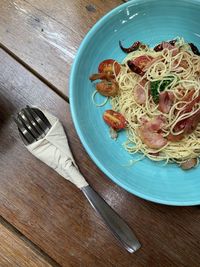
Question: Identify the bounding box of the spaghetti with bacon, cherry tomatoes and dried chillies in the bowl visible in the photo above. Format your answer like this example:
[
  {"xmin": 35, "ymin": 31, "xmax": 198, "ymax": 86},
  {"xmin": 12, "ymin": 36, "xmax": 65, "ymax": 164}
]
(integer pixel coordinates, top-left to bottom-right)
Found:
[{"xmin": 90, "ymin": 37, "xmax": 200, "ymax": 169}]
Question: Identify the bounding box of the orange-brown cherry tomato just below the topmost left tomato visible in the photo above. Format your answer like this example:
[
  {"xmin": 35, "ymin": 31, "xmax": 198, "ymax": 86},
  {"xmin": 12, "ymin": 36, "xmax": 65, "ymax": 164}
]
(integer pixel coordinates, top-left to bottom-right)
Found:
[{"xmin": 96, "ymin": 80, "xmax": 119, "ymax": 96}]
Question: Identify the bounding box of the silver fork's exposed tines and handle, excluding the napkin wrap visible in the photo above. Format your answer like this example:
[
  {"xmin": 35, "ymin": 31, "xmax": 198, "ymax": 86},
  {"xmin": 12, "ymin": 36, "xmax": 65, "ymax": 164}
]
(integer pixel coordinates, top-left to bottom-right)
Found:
[{"xmin": 14, "ymin": 106, "xmax": 141, "ymax": 253}]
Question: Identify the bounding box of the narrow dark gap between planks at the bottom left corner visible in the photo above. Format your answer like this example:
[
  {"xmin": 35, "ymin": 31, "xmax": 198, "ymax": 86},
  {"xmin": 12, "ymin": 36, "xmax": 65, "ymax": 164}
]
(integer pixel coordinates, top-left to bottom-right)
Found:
[{"xmin": 0, "ymin": 216, "xmax": 61, "ymax": 267}]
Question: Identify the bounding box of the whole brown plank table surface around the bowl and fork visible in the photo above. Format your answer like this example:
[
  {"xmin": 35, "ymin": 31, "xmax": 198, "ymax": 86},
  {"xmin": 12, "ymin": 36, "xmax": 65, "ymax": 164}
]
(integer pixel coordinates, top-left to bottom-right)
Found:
[{"xmin": 0, "ymin": 0, "xmax": 200, "ymax": 267}]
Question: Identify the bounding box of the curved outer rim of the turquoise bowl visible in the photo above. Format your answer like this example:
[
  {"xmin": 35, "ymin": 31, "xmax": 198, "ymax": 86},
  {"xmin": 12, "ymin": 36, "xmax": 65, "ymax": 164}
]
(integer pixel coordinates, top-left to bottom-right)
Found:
[{"xmin": 69, "ymin": 0, "xmax": 200, "ymax": 206}]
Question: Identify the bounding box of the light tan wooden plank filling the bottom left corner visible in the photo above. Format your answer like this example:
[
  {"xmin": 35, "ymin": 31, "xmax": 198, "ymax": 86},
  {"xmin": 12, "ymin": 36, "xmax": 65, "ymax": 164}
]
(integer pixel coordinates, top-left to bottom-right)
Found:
[{"xmin": 0, "ymin": 220, "xmax": 54, "ymax": 267}]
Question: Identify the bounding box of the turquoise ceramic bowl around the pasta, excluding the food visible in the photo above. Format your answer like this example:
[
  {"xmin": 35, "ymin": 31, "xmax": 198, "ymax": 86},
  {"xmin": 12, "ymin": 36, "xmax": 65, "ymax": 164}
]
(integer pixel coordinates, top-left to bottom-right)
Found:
[{"xmin": 70, "ymin": 0, "xmax": 200, "ymax": 206}]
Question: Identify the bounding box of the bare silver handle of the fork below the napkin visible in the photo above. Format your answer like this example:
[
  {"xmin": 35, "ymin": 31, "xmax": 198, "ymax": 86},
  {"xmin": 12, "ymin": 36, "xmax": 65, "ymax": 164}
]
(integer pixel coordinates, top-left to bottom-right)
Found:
[{"xmin": 81, "ymin": 185, "xmax": 141, "ymax": 253}]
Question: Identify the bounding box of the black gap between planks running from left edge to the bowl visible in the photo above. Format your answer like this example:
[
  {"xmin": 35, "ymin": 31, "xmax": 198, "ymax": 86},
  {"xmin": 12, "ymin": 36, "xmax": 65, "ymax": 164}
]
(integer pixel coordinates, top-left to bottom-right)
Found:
[{"xmin": 0, "ymin": 43, "xmax": 69, "ymax": 104}]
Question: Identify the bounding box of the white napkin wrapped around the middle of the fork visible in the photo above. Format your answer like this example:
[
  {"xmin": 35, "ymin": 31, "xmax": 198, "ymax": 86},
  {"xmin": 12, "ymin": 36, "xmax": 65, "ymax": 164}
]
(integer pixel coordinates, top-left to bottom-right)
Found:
[{"xmin": 26, "ymin": 111, "xmax": 88, "ymax": 189}]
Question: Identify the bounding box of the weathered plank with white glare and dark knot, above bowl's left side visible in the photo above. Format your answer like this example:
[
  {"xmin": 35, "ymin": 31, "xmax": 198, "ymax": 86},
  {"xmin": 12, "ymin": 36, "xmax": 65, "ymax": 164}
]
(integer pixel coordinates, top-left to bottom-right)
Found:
[{"xmin": 0, "ymin": 0, "xmax": 122, "ymax": 95}]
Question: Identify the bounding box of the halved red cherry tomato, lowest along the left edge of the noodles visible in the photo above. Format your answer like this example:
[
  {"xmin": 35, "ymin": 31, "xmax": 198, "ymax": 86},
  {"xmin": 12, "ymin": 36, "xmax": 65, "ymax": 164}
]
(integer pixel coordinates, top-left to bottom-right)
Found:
[{"xmin": 103, "ymin": 109, "xmax": 127, "ymax": 131}]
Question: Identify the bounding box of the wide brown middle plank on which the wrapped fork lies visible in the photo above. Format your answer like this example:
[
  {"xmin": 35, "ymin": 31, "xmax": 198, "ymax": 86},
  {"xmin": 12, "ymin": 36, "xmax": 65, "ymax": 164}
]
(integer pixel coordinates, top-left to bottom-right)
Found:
[{"xmin": 0, "ymin": 51, "xmax": 200, "ymax": 267}]
